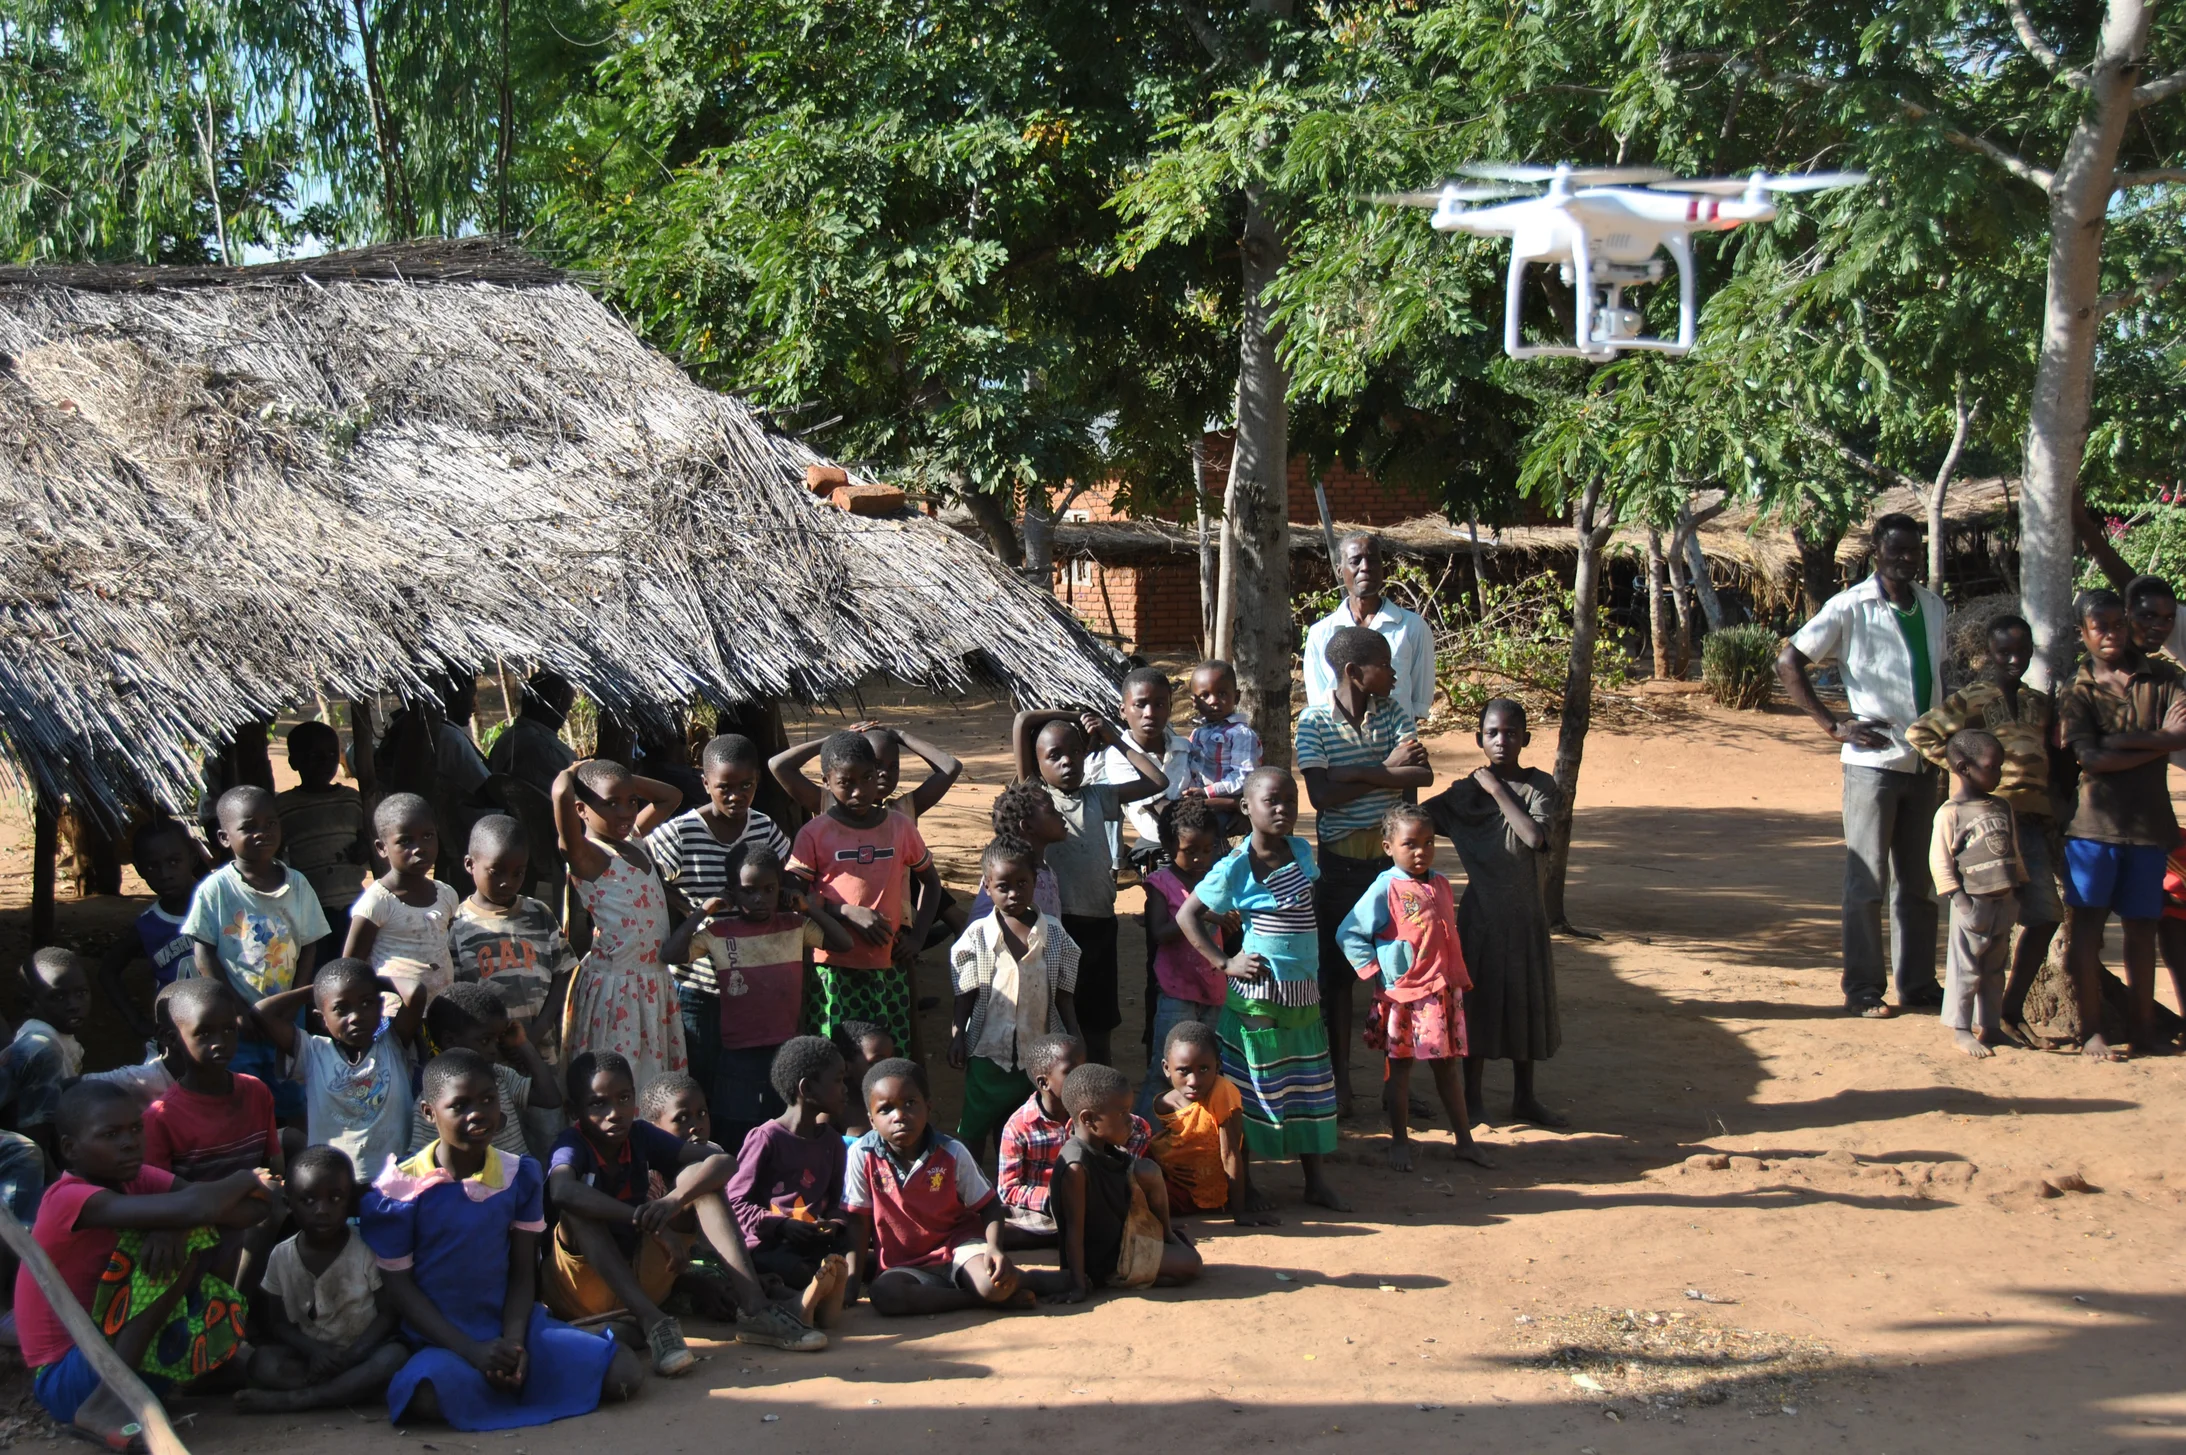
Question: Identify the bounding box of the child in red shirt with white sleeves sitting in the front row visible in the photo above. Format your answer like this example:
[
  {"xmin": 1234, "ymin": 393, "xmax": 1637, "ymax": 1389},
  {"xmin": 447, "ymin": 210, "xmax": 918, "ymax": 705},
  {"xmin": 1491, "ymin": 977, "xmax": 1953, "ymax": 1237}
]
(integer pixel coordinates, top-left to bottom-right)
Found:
[{"xmin": 842, "ymin": 1057, "xmax": 1034, "ymax": 1315}]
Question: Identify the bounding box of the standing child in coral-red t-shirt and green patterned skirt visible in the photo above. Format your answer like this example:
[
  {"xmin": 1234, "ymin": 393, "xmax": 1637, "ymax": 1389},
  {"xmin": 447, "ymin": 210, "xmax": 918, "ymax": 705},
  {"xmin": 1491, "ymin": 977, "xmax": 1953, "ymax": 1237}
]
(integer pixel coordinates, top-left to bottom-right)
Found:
[{"xmin": 789, "ymin": 732, "xmax": 942, "ymax": 1049}]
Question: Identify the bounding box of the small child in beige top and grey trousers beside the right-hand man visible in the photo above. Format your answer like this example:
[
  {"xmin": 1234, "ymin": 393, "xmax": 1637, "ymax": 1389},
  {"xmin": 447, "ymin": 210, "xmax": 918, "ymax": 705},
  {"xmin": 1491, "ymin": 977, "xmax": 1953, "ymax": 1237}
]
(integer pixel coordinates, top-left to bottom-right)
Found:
[{"xmin": 1928, "ymin": 728, "xmax": 2026, "ymax": 1060}]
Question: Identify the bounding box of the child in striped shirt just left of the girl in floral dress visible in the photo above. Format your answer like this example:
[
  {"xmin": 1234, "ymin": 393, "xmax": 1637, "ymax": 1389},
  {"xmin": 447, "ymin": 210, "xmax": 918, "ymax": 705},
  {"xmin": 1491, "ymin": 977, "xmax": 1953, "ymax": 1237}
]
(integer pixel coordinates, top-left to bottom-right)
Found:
[{"xmin": 448, "ymin": 813, "xmax": 577, "ymax": 1044}]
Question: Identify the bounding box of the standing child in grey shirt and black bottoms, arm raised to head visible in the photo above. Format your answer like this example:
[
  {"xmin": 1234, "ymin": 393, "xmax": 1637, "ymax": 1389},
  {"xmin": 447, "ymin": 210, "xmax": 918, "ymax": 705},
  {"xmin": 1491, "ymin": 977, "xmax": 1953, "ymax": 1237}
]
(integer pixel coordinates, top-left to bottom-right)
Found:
[{"xmin": 1012, "ymin": 710, "xmax": 1170, "ymax": 1062}]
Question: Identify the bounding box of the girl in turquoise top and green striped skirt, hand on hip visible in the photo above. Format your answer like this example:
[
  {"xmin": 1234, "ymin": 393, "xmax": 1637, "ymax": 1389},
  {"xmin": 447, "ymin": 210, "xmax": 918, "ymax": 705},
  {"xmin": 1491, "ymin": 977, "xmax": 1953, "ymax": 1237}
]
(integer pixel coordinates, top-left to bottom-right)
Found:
[{"xmin": 1176, "ymin": 767, "xmax": 1347, "ymax": 1213}]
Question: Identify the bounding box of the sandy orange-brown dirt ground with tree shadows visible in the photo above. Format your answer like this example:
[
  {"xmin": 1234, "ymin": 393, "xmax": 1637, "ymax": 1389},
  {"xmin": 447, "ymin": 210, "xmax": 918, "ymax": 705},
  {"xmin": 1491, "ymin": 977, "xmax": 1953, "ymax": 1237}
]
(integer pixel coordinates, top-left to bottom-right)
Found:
[{"xmin": 0, "ymin": 685, "xmax": 2186, "ymax": 1455}]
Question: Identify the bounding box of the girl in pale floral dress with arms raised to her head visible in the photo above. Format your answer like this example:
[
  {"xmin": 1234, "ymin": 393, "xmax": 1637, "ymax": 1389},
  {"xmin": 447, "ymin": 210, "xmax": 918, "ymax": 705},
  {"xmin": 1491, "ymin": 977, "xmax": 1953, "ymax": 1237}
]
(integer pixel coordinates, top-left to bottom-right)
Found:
[{"xmin": 553, "ymin": 758, "xmax": 686, "ymax": 1081}]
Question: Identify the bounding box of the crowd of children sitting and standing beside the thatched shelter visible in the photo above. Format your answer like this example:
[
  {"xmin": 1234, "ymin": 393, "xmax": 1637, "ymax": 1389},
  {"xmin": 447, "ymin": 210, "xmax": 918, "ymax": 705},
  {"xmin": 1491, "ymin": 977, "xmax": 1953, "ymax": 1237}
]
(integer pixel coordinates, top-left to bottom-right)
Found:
[{"xmin": 0, "ymin": 629, "xmax": 1556, "ymax": 1446}]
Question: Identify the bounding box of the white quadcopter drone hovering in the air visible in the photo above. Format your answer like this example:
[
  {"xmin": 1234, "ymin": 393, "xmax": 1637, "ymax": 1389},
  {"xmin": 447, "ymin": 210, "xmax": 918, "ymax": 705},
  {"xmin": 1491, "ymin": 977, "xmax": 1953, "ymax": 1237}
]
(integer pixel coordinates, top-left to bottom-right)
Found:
[{"xmin": 1375, "ymin": 162, "xmax": 1867, "ymax": 363}]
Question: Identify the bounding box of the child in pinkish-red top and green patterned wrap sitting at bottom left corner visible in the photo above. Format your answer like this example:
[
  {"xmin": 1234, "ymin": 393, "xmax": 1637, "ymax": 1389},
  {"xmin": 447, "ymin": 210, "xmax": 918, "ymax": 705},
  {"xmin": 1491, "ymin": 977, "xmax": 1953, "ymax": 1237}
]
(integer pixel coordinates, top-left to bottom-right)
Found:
[{"xmin": 15, "ymin": 1081, "xmax": 280, "ymax": 1451}]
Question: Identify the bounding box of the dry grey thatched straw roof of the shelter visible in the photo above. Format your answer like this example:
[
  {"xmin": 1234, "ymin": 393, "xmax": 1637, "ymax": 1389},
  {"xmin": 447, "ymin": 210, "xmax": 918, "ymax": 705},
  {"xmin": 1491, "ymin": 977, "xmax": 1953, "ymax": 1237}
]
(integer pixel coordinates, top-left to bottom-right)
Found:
[{"xmin": 0, "ymin": 240, "xmax": 1121, "ymax": 813}]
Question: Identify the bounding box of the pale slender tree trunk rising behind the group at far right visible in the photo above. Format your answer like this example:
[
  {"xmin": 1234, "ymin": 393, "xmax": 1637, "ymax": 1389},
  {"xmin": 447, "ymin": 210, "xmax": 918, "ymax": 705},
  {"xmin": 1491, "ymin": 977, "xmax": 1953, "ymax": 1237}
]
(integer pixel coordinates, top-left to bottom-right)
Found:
[{"xmin": 2020, "ymin": 0, "xmax": 2153, "ymax": 693}]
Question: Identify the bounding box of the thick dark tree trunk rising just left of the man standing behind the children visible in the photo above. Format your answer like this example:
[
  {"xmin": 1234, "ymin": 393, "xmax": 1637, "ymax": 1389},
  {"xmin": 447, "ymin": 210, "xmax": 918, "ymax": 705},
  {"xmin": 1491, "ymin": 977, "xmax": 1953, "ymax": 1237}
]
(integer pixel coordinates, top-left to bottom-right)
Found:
[{"xmin": 1229, "ymin": 175, "xmax": 1294, "ymax": 767}]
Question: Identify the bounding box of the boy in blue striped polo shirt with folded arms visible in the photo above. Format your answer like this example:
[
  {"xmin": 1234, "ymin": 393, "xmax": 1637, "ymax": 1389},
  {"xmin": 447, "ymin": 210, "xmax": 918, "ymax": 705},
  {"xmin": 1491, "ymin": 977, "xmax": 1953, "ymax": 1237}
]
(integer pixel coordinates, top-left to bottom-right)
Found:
[{"xmin": 1296, "ymin": 627, "xmax": 1434, "ymax": 1116}]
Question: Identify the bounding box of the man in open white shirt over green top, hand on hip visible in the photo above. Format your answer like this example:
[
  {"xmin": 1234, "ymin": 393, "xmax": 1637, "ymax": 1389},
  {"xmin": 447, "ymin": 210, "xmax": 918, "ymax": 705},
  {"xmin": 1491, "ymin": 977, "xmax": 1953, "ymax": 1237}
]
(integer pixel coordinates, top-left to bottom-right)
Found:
[{"xmin": 1777, "ymin": 513, "xmax": 1943, "ymax": 1018}]
